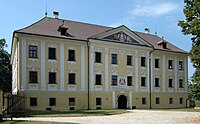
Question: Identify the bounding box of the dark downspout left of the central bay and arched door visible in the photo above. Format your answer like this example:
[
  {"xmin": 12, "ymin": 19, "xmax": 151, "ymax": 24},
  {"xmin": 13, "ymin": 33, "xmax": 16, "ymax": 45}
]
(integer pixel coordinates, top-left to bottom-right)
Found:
[{"xmin": 87, "ymin": 39, "xmax": 90, "ymax": 110}]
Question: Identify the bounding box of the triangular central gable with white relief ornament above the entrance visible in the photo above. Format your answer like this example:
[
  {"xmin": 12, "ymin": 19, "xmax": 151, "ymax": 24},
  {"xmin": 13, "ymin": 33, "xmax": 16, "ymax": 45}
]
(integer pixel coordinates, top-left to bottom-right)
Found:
[{"xmin": 91, "ymin": 25, "xmax": 151, "ymax": 47}]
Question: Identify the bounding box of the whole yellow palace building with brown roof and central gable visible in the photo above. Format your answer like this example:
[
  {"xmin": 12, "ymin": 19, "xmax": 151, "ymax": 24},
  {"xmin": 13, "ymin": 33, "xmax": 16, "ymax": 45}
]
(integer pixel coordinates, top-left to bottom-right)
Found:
[{"xmin": 11, "ymin": 13, "xmax": 188, "ymax": 110}]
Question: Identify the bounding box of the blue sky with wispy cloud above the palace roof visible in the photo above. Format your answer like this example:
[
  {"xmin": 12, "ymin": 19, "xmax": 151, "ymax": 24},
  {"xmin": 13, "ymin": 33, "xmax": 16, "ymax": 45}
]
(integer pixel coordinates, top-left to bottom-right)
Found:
[{"xmin": 0, "ymin": 0, "xmax": 194, "ymax": 78}]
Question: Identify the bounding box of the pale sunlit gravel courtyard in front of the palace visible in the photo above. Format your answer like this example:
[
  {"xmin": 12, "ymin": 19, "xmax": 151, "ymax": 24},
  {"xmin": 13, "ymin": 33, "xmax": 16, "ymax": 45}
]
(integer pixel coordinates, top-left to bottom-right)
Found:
[{"xmin": 13, "ymin": 110, "xmax": 200, "ymax": 124}]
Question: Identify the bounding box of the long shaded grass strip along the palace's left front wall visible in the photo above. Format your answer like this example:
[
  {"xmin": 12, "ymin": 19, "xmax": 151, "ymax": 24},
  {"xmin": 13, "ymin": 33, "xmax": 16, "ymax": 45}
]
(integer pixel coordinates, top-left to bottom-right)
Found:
[{"xmin": 25, "ymin": 109, "xmax": 127, "ymax": 117}]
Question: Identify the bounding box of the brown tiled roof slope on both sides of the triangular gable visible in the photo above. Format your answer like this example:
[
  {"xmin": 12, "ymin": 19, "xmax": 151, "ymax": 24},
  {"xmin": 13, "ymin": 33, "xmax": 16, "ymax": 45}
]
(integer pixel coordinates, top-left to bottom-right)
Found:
[{"xmin": 16, "ymin": 17, "xmax": 187, "ymax": 53}]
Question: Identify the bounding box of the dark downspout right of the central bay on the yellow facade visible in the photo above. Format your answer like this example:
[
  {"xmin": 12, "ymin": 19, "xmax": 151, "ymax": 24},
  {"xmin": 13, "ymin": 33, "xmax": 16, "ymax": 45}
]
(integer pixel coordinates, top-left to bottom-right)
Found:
[{"xmin": 149, "ymin": 49, "xmax": 154, "ymax": 109}]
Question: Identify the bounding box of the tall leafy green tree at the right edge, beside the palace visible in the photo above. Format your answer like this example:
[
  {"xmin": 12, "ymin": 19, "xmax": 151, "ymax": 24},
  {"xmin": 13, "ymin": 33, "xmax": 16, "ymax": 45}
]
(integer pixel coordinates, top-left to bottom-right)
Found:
[{"xmin": 178, "ymin": 0, "xmax": 200, "ymax": 100}]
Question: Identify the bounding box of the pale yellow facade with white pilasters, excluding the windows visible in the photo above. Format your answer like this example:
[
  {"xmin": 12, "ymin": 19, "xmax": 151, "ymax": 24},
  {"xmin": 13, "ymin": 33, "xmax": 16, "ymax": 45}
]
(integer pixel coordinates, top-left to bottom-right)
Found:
[{"xmin": 12, "ymin": 16, "xmax": 188, "ymax": 110}]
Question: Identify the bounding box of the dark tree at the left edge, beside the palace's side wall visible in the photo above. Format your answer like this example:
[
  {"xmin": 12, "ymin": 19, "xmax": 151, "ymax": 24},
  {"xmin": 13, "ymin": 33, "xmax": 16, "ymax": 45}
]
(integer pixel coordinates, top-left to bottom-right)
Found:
[{"xmin": 0, "ymin": 39, "xmax": 12, "ymax": 91}]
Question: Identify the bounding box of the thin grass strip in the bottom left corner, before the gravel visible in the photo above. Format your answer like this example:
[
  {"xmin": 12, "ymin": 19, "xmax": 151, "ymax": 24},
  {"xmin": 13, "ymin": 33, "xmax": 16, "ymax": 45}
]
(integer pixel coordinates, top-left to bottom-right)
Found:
[{"xmin": 0, "ymin": 121, "xmax": 75, "ymax": 124}]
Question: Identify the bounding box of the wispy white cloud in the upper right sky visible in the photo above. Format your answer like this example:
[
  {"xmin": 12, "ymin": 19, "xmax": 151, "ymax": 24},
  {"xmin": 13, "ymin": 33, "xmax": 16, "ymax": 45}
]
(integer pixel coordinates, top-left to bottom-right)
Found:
[{"xmin": 130, "ymin": 2, "xmax": 178, "ymax": 17}]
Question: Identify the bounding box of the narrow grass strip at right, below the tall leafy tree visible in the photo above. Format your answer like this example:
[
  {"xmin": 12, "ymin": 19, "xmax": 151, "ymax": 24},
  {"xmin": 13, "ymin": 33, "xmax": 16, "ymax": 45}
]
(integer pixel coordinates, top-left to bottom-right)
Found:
[{"xmin": 151, "ymin": 108, "xmax": 200, "ymax": 112}]
